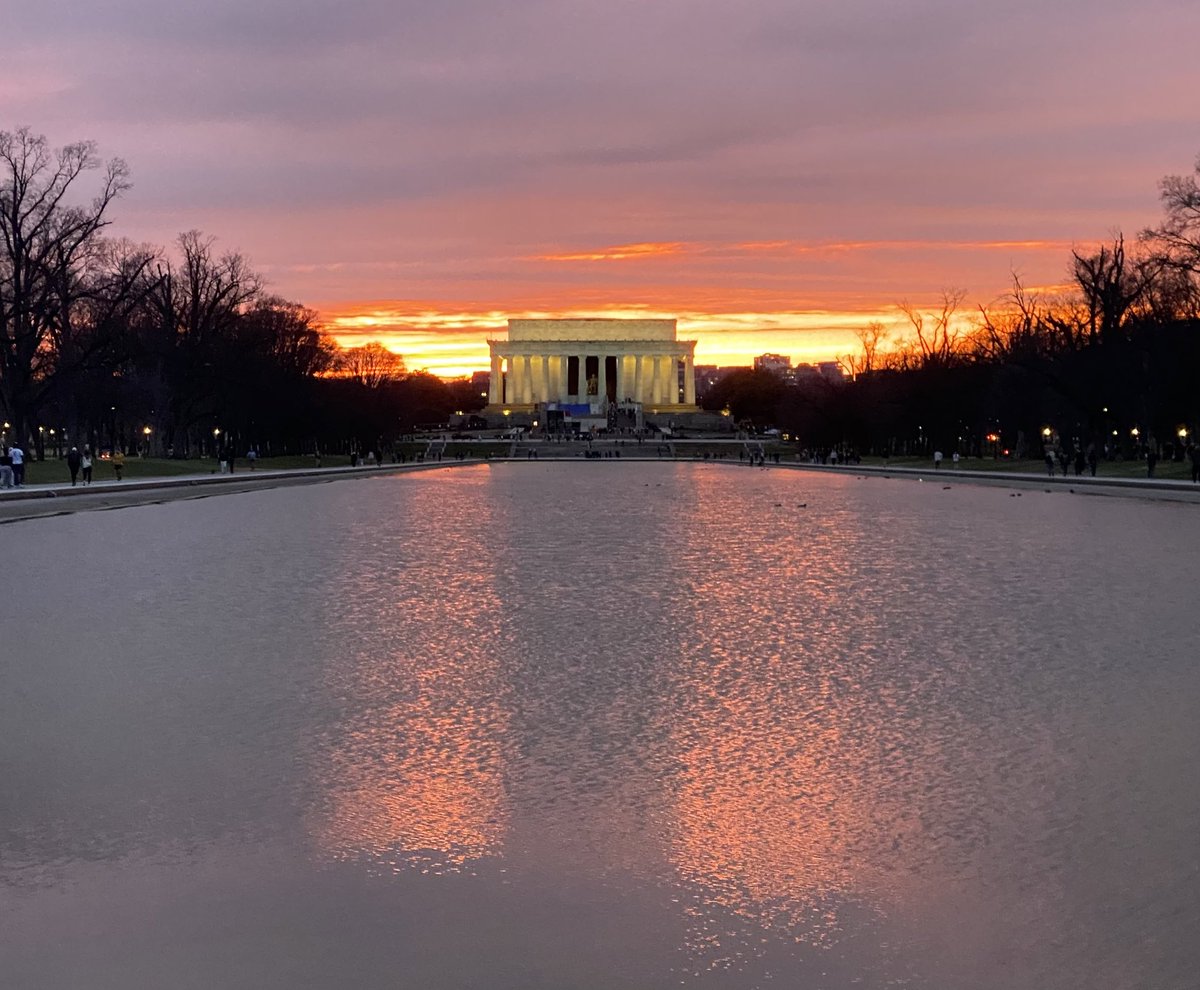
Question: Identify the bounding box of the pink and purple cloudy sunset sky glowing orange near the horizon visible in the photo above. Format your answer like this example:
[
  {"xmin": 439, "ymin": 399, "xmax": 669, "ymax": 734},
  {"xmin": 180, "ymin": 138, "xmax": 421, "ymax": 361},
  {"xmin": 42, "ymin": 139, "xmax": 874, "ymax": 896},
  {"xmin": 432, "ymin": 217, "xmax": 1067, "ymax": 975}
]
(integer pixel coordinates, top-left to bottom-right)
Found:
[{"xmin": 0, "ymin": 0, "xmax": 1200, "ymax": 376}]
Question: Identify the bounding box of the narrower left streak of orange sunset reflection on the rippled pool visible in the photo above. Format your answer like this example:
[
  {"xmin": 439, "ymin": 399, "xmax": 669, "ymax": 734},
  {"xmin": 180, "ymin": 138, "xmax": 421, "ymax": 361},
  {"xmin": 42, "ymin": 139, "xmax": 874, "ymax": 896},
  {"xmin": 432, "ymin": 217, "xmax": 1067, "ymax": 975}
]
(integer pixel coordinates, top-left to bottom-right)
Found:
[{"xmin": 311, "ymin": 475, "xmax": 509, "ymax": 870}]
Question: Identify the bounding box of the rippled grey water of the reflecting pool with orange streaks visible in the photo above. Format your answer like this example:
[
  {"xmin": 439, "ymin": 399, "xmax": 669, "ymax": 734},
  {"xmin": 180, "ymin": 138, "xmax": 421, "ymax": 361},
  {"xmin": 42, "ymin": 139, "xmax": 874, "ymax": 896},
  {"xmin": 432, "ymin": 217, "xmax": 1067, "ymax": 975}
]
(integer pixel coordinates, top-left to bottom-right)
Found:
[{"xmin": 0, "ymin": 462, "xmax": 1200, "ymax": 990}]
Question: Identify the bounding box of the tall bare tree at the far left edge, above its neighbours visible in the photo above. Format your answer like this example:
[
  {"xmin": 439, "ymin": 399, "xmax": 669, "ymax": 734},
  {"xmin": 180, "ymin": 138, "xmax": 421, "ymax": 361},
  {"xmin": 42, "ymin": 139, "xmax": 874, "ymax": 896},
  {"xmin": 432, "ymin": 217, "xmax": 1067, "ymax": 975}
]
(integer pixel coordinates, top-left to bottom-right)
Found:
[{"xmin": 0, "ymin": 128, "xmax": 130, "ymax": 438}]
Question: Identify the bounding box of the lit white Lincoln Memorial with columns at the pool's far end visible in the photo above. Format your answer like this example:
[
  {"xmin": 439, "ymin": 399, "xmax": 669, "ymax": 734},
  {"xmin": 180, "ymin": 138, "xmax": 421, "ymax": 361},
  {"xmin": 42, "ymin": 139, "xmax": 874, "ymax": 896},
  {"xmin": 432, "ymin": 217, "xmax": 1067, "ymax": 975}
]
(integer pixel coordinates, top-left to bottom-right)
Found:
[{"xmin": 487, "ymin": 319, "xmax": 696, "ymax": 413}]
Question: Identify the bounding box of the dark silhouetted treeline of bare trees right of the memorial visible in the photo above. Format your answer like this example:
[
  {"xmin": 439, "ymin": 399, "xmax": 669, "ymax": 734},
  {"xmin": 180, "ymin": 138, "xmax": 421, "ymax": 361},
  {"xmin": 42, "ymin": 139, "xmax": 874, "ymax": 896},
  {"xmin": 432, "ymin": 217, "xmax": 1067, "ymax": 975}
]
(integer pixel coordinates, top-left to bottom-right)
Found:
[{"xmin": 706, "ymin": 161, "xmax": 1200, "ymax": 456}]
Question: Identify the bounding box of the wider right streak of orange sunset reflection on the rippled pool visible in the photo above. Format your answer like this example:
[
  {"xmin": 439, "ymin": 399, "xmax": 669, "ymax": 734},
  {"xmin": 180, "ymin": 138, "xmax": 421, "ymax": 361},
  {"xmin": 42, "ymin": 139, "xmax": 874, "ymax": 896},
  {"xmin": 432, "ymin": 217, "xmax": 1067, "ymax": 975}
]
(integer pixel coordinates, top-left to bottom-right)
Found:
[{"xmin": 667, "ymin": 474, "xmax": 907, "ymax": 955}]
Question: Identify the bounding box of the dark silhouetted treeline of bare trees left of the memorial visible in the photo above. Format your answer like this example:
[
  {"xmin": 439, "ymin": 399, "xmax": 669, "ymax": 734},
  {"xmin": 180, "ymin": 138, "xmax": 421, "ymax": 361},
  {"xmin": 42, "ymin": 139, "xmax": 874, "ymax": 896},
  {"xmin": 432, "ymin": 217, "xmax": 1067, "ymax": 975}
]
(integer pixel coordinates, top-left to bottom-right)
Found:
[{"xmin": 0, "ymin": 130, "xmax": 482, "ymax": 457}]
